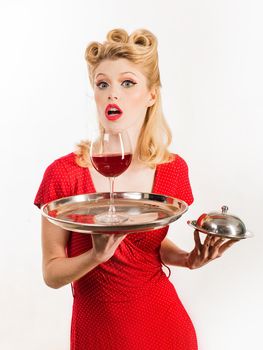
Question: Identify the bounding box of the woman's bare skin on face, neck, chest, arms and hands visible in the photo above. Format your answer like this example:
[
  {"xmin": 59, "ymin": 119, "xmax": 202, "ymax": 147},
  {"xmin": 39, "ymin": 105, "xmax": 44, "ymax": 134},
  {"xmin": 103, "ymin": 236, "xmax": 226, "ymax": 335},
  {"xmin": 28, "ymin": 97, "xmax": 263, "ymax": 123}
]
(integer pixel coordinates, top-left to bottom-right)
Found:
[{"xmin": 42, "ymin": 59, "xmax": 235, "ymax": 288}]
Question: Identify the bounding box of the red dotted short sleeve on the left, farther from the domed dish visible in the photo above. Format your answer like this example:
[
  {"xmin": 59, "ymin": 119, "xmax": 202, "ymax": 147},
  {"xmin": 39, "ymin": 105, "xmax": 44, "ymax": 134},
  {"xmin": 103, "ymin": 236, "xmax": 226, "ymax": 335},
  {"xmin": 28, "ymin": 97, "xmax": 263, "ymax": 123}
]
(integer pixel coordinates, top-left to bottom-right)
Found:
[{"xmin": 34, "ymin": 160, "xmax": 71, "ymax": 208}]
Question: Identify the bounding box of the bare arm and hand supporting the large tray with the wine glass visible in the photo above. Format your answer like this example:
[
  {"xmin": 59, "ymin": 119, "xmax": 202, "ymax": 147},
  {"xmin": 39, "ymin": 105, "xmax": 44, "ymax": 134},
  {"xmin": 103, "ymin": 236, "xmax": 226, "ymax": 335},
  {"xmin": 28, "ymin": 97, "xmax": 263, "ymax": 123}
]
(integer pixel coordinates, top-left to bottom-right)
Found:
[{"xmin": 42, "ymin": 218, "xmax": 125, "ymax": 288}]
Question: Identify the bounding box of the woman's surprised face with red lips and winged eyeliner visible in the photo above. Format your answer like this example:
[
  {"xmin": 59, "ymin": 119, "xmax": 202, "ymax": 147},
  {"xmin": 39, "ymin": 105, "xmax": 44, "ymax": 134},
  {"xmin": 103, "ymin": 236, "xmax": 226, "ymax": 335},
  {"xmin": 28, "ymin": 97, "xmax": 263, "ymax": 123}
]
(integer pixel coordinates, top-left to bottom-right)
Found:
[{"xmin": 94, "ymin": 58, "xmax": 156, "ymax": 130}]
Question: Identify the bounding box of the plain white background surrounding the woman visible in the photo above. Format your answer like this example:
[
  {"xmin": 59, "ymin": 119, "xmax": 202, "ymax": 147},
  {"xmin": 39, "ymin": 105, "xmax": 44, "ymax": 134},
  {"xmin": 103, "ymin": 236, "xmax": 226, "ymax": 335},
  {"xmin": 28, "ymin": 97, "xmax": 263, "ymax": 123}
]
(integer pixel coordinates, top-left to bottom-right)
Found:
[{"xmin": 0, "ymin": 0, "xmax": 263, "ymax": 350}]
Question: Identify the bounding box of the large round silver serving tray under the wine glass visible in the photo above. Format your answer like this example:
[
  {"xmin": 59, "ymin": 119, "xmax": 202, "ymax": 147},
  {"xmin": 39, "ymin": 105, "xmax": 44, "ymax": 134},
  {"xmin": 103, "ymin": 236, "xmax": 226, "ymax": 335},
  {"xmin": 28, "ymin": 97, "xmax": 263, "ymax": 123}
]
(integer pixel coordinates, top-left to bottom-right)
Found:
[{"xmin": 41, "ymin": 192, "xmax": 188, "ymax": 234}]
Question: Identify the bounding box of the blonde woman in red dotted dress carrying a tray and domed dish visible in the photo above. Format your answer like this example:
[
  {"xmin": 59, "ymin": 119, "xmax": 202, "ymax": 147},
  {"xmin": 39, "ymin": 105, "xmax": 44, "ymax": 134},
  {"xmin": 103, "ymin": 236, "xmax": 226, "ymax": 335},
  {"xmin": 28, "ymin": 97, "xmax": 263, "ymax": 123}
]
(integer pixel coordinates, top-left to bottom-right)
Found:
[{"xmin": 35, "ymin": 29, "xmax": 237, "ymax": 350}]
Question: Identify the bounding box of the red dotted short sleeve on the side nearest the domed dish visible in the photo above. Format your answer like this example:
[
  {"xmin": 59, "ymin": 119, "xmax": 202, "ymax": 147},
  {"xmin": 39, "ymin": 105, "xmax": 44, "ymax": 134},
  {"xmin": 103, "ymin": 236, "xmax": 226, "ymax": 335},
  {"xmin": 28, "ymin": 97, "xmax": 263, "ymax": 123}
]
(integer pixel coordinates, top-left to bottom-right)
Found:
[{"xmin": 175, "ymin": 155, "xmax": 194, "ymax": 205}]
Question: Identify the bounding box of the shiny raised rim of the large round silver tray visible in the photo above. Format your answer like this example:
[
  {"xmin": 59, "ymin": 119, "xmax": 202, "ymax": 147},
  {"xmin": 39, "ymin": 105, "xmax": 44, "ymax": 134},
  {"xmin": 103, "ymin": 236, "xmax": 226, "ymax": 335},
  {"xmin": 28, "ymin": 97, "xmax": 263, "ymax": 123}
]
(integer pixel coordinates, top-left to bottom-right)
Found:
[{"xmin": 40, "ymin": 191, "xmax": 189, "ymax": 234}]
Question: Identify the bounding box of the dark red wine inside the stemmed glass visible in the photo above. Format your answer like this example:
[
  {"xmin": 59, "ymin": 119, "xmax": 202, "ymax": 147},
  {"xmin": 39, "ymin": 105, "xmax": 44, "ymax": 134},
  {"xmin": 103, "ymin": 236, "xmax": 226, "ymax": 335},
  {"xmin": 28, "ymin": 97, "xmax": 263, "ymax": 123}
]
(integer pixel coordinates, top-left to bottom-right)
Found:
[{"xmin": 92, "ymin": 153, "xmax": 132, "ymax": 177}]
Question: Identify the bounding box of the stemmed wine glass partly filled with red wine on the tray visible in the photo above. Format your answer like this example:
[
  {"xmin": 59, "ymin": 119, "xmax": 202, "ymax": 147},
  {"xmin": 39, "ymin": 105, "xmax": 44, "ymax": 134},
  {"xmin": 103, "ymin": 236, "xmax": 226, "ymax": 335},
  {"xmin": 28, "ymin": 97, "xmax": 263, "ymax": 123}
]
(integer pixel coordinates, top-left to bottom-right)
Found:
[{"xmin": 90, "ymin": 130, "xmax": 132, "ymax": 224}]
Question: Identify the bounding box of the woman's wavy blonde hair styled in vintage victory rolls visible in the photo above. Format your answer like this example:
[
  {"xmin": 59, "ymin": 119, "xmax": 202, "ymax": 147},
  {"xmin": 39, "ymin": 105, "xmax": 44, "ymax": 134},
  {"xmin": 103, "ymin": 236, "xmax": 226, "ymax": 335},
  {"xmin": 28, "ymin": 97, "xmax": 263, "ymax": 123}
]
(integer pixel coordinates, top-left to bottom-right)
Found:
[{"xmin": 76, "ymin": 29, "xmax": 175, "ymax": 168}]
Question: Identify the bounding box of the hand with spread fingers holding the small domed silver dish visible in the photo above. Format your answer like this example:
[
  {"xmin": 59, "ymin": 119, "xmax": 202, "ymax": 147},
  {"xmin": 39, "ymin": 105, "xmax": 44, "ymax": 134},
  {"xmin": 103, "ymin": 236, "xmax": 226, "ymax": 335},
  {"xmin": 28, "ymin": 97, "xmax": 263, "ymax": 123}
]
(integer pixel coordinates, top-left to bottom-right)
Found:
[{"xmin": 187, "ymin": 230, "xmax": 238, "ymax": 269}]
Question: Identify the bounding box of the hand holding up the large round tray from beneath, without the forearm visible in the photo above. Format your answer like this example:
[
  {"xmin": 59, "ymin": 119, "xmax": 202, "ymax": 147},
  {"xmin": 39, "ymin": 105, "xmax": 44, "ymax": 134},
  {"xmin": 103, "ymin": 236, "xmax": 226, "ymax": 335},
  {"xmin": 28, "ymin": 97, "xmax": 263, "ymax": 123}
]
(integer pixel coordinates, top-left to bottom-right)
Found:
[{"xmin": 91, "ymin": 233, "xmax": 127, "ymax": 263}]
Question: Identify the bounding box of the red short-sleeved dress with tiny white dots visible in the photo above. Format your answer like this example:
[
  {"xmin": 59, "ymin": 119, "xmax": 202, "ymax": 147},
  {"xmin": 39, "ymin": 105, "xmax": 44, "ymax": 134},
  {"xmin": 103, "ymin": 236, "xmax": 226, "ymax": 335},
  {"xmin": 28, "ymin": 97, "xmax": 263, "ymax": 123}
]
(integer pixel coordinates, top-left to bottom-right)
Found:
[{"xmin": 35, "ymin": 153, "xmax": 197, "ymax": 350}]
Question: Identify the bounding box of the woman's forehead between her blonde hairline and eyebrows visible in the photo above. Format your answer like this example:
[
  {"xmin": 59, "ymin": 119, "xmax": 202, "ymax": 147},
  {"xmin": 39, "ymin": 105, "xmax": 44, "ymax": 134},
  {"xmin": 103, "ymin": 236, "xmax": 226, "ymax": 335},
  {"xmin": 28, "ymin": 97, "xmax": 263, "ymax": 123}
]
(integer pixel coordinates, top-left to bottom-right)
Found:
[{"xmin": 94, "ymin": 58, "xmax": 146, "ymax": 80}]
